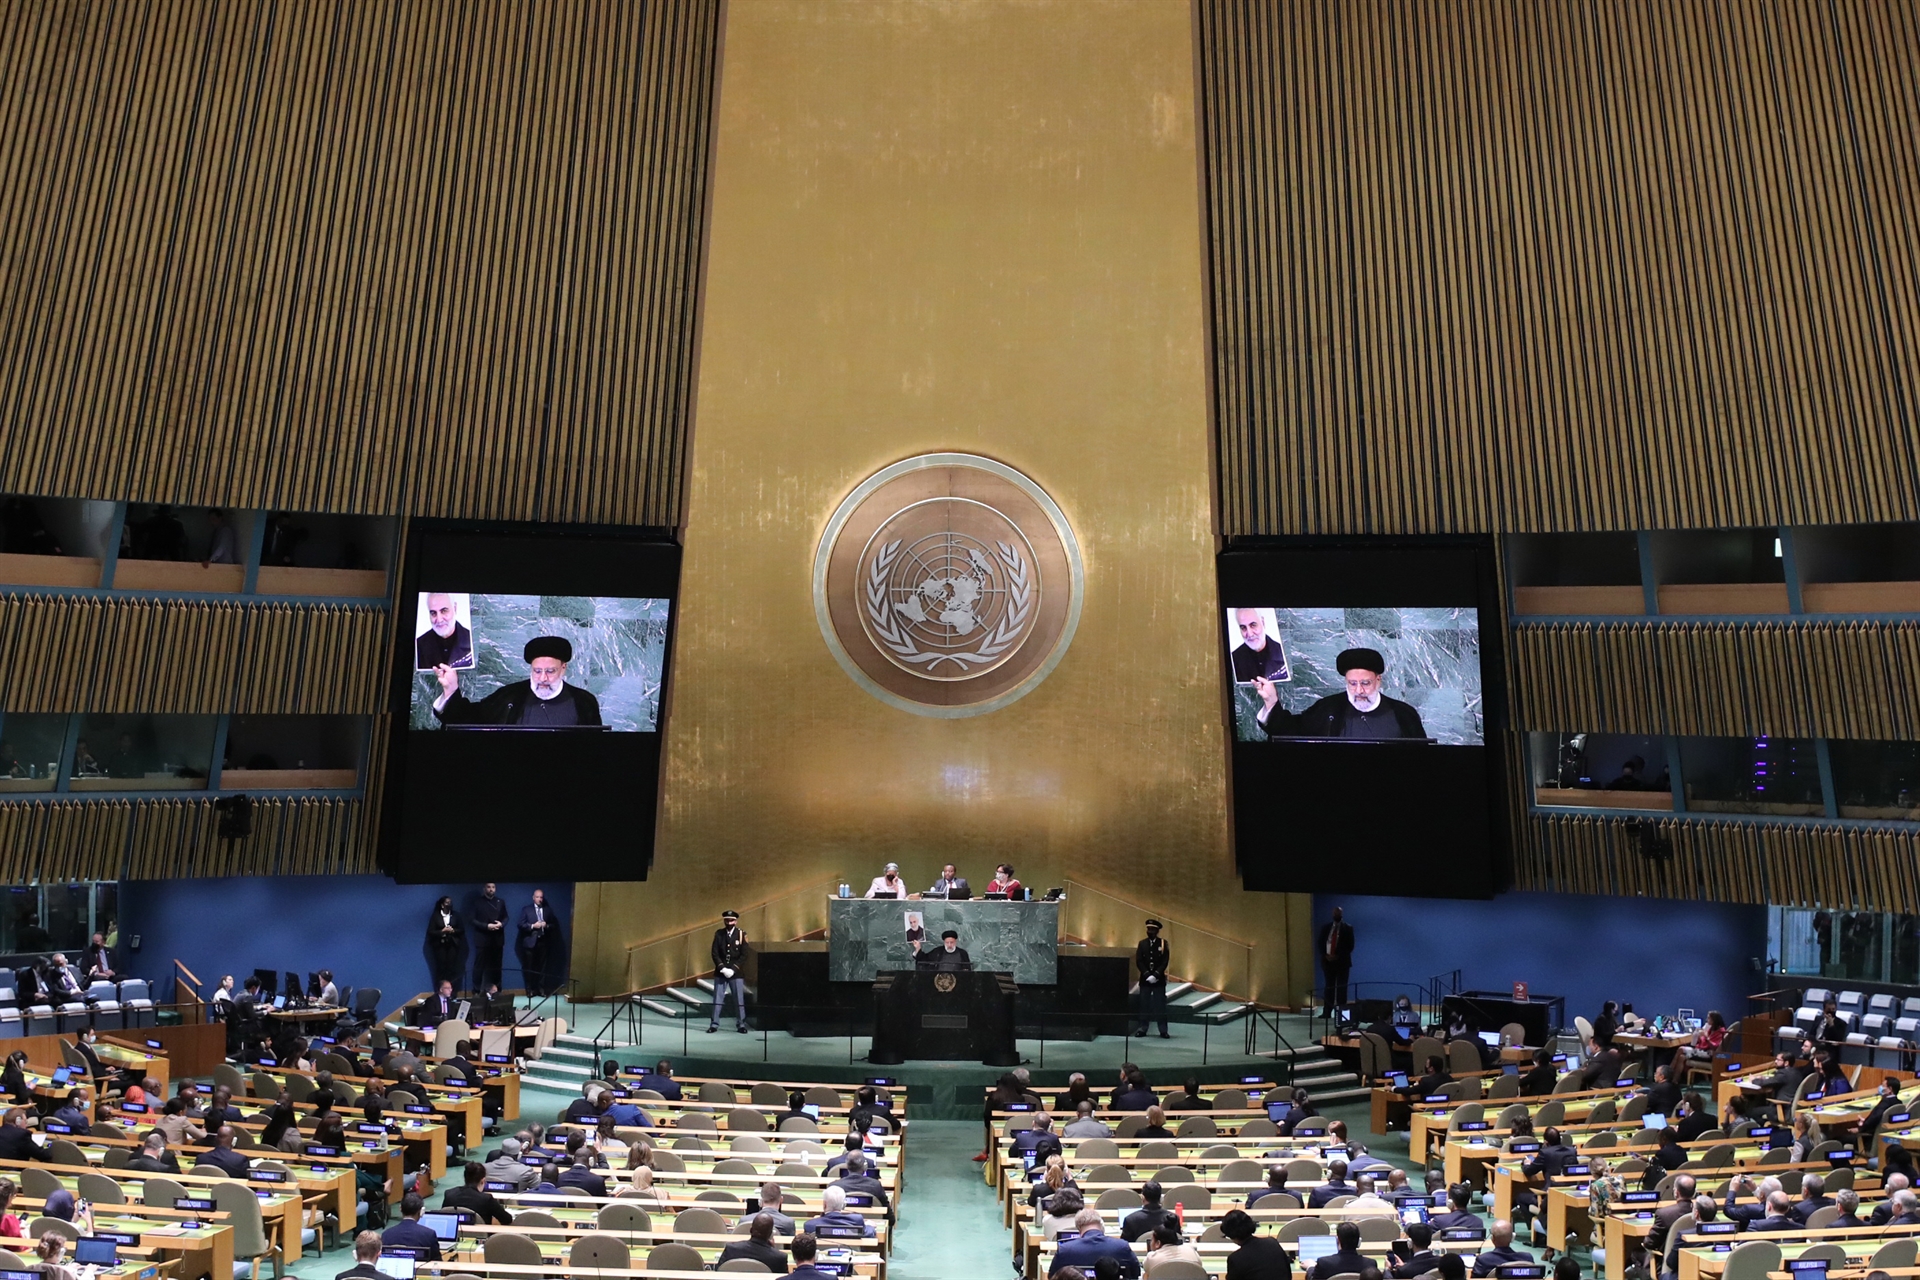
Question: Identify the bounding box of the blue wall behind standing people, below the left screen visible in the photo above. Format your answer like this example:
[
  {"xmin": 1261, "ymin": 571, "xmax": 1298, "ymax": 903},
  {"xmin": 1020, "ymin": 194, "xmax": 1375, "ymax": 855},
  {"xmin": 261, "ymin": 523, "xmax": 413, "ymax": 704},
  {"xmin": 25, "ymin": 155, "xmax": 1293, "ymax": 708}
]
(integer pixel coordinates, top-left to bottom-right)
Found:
[{"xmin": 121, "ymin": 875, "xmax": 574, "ymax": 1013}]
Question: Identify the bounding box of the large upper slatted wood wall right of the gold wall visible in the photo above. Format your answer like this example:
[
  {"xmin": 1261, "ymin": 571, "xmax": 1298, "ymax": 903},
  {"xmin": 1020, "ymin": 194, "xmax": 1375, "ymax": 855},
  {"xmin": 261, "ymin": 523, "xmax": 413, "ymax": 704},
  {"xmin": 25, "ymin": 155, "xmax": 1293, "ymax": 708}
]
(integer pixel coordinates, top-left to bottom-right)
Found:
[{"xmin": 1196, "ymin": 0, "xmax": 1920, "ymax": 535}]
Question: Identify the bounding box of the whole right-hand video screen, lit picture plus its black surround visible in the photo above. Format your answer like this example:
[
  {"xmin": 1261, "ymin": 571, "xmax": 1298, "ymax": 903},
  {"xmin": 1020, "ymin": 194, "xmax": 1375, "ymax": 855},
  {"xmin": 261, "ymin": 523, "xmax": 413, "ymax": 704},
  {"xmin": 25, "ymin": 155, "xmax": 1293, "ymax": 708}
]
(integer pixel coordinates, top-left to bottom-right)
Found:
[{"xmin": 1219, "ymin": 537, "xmax": 1505, "ymax": 898}]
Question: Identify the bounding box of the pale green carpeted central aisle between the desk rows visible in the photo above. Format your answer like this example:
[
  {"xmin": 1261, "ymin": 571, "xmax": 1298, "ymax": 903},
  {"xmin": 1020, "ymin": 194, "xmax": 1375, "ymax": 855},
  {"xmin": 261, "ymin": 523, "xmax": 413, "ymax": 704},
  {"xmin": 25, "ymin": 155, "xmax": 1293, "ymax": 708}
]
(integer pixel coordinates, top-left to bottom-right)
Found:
[{"xmin": 887, "ymin": 1121, "xmax": 1014, "ymax": 1280}]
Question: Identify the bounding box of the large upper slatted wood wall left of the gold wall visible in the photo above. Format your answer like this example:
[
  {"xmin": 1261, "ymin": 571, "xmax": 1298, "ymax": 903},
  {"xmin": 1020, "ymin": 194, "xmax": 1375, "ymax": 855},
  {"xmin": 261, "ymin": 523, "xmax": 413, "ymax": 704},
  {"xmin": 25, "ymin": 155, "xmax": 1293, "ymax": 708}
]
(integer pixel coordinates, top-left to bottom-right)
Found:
[{"xmin": 0, "ymin": 0, "xmax": 718, "ymax": 526}]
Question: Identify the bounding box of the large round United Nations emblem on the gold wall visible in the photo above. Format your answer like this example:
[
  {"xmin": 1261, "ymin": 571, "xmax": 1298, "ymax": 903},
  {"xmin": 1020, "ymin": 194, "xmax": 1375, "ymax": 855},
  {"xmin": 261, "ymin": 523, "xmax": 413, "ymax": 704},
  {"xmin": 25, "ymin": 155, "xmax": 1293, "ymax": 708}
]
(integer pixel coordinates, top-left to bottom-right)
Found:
[{"xmin": 814, "ymin": 453, "xmax": 1083, "ymax": 716}]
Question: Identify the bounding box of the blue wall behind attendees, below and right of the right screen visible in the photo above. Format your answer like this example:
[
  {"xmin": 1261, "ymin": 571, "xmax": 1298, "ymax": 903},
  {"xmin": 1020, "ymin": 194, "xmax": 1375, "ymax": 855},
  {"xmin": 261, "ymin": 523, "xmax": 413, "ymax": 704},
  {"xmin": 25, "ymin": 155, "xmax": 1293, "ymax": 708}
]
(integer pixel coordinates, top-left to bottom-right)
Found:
[{"xmin": 1313, "ymin": 892, "xmax": 1768, "ymax": 1025}]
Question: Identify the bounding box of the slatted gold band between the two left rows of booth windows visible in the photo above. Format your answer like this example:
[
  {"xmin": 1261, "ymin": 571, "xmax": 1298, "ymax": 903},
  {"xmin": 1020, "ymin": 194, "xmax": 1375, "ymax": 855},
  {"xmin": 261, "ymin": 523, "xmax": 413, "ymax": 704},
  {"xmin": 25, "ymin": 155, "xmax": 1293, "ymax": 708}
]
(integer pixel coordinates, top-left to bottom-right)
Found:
[{"xmin": 0, "ymin": 595, "xmax": 390, "ymax": 716}]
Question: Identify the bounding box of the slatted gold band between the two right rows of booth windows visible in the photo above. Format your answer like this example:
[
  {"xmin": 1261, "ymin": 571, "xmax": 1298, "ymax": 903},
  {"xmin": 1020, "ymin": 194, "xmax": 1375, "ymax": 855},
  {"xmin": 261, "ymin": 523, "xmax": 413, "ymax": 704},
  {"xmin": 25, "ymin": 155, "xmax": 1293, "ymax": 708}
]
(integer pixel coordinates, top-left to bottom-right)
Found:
[{"xmin": 1509, "ymin": 620, "xmax": 1920, "ymax": 739}]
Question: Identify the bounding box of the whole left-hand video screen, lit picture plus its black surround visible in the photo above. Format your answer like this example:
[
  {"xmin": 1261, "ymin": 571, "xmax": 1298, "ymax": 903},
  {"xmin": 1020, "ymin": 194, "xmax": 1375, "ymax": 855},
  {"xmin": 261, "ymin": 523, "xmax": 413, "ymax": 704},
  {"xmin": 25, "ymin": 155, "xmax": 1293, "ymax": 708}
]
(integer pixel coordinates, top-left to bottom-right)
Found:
[{"xmin": 380, "ymin": 520, "xmax": 680, "ymax": 883}]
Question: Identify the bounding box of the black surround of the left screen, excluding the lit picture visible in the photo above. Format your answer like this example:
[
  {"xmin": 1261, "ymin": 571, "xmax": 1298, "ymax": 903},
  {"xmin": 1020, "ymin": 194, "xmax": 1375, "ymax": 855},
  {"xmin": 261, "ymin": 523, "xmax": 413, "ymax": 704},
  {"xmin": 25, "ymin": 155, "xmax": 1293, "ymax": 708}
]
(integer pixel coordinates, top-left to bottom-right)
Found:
[{"xmin": 378, "ymin": 518, "xmax": 682, "ymax": 885}]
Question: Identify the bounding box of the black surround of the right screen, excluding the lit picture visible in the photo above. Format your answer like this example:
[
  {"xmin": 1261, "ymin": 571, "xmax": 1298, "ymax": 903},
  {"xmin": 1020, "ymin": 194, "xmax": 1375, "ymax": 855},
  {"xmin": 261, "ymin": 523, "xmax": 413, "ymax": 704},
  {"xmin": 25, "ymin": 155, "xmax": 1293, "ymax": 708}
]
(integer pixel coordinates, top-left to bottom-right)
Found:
[{"xmin": 1215, "ymin": 533, "xmax": 1513, "ymax": 900}]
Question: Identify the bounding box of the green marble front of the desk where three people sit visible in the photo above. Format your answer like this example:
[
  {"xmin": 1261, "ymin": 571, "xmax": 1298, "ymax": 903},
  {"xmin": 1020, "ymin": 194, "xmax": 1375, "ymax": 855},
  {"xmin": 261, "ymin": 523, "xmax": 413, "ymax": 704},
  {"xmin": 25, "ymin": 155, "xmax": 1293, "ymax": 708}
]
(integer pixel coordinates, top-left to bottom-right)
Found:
[{"xmin": 828, "ymin": 898, "xmax": 1060, "ymax": 986}]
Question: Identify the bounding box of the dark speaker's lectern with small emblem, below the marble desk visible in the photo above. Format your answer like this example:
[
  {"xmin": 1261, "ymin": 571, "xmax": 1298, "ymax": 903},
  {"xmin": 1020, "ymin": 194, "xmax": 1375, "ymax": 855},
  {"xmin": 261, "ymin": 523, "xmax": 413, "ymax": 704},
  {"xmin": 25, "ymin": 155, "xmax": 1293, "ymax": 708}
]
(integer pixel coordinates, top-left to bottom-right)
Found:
[{"xmin": 866, "ymin": 969, "xmax": 1020, "ymax": 1067}]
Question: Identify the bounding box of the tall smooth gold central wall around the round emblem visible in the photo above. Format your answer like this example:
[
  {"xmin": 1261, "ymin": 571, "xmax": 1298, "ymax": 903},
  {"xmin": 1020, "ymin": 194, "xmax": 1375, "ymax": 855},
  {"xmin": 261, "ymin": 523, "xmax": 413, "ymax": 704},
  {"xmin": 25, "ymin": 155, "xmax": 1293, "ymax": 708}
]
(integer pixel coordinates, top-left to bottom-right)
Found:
[{"xmin": 576, "ymin": 0, "xmax": 1306, "ymax": 1000}]
